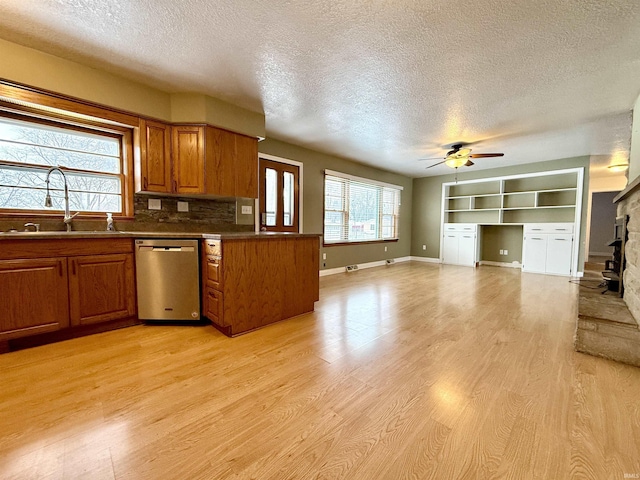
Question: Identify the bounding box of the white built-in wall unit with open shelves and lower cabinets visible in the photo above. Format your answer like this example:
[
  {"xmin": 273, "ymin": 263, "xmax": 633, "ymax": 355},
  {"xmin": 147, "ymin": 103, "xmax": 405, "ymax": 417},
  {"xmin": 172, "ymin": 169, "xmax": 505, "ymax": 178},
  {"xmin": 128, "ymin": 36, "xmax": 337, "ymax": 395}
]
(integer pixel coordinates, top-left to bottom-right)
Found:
[{"xmin": 440, "ymin": 167, "xmax": 584, "ymax": 275}]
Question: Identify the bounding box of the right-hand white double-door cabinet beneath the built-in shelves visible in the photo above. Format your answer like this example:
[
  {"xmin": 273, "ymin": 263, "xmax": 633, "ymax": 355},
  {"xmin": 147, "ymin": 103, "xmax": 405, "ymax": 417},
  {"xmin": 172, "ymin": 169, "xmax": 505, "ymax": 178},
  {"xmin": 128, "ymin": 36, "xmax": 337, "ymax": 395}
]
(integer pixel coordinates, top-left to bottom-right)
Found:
[{"xmin": 522, "ymin": 223, "xmax": 574, "ymax": 275}]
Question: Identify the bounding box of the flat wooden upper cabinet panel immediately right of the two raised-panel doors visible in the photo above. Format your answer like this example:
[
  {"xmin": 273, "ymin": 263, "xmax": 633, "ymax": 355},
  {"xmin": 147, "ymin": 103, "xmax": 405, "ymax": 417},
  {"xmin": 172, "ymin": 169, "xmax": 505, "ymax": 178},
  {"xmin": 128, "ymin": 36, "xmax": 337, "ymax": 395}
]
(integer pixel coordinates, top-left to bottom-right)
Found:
[{"xmin": 206, "ymin": 127, "xmax": 239, "ymax": 197}]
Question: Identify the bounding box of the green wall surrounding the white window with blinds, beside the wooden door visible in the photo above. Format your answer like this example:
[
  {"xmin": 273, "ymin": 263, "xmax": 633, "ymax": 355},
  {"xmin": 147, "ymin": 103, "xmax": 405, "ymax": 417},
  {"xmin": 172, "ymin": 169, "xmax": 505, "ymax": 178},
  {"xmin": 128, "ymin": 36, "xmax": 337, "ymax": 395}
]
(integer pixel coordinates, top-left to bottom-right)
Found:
[{"xmin": 258, "ymin": 139, "xmax": 412, "ymax": 269}]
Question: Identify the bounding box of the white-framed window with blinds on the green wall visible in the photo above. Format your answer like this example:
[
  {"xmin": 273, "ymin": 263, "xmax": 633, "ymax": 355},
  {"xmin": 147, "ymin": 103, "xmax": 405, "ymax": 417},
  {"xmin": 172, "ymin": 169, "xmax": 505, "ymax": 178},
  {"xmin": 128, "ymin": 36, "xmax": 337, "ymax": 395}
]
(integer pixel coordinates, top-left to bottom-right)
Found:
[{"xmin": 324, "ymin": 170, "xmax": 402, "ymax": 243}]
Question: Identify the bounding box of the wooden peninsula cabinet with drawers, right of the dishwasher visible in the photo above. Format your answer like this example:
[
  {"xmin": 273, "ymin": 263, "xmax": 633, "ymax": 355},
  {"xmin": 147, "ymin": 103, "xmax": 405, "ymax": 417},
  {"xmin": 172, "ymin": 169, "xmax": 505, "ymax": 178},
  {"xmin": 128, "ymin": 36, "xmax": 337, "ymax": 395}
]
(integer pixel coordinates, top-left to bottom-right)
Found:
[{"xmin": 202, "ymin": 235, "xmax": 319, "ymax": 336}]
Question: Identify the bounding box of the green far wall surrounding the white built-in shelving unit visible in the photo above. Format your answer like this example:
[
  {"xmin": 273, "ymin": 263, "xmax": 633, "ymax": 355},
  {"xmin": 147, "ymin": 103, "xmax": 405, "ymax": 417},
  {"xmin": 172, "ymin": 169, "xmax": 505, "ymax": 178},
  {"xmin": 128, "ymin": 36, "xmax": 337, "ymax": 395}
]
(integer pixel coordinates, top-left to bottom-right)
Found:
[{"xmin": 411, "ymin": 157, "xmax": 589, "ymax": 266}]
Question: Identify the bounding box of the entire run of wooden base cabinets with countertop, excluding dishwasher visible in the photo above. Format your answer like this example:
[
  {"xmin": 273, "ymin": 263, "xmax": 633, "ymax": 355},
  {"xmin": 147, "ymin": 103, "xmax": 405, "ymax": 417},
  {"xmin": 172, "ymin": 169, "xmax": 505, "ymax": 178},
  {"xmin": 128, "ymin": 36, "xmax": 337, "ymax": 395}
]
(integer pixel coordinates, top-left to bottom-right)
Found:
[{"xmin": 0, "ymin": 231, "xmax": 319, "ymax": 351}]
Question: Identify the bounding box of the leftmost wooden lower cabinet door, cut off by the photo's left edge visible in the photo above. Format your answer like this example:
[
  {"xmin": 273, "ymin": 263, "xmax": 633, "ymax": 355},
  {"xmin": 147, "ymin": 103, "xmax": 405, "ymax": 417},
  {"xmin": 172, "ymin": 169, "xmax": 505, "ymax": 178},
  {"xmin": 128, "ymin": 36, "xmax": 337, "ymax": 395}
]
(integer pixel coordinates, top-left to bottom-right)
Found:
[{"xmin": 0, "ymin": 258, "xmax": 69, "ymax": 340}]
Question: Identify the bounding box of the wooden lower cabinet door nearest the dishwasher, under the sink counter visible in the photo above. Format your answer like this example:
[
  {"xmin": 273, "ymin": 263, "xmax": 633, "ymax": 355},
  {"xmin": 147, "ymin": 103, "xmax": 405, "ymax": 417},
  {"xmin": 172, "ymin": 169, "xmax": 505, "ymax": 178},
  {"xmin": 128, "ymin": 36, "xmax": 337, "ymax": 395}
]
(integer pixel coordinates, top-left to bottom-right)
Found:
[{"xmin": 69, "ymin": 253, "xmax": 136, "ymax": 325}]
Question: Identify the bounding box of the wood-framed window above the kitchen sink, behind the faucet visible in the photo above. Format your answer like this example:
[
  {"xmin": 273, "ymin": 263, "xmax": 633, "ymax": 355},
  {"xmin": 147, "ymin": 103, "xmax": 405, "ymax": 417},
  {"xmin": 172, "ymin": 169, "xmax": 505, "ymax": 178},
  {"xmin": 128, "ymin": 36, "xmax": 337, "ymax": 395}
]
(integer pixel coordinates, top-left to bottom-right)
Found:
[{"xmin": 0, "ymin": 113, "xmax": 124, "ymax": 214}]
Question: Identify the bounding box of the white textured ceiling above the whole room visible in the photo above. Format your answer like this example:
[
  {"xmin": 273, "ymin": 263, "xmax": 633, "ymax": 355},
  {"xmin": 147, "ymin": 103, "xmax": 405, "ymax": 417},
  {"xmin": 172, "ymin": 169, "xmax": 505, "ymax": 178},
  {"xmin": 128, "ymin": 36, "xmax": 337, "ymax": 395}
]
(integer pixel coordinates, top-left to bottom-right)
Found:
[{"xmin": 0, "ymin": 0, "xmax": 640, "ymax": 177}]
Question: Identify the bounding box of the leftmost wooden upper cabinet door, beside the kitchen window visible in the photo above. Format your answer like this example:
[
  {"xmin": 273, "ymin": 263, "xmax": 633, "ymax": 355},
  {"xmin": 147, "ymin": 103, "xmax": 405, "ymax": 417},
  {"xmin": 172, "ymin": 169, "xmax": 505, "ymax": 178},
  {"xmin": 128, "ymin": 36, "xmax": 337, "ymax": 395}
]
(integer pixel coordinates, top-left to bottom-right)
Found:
[{"xmin": 140, "ymin": 120, "xmax": 172, "ymax": 193}]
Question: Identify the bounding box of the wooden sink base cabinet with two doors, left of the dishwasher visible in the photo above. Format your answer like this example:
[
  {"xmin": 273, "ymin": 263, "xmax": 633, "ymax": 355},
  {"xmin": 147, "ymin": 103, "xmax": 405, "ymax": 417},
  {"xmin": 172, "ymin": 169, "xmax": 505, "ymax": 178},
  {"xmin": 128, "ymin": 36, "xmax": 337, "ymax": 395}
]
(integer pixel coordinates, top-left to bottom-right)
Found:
[{"xmin": 0, "ymin": 238, "xmax": 139, "ymax": 344}]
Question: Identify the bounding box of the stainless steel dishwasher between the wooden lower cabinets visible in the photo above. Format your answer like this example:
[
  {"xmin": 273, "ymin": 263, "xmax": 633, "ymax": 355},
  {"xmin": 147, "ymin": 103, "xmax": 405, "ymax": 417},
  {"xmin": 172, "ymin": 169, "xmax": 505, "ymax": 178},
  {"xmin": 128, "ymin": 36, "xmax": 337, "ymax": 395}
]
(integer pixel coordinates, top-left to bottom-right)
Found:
[{"xmin": 135, "ymin": 239, "xmax": 200, "ymax": 321}]
